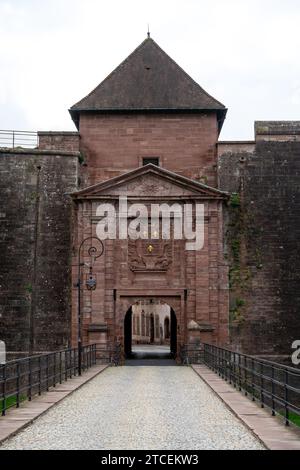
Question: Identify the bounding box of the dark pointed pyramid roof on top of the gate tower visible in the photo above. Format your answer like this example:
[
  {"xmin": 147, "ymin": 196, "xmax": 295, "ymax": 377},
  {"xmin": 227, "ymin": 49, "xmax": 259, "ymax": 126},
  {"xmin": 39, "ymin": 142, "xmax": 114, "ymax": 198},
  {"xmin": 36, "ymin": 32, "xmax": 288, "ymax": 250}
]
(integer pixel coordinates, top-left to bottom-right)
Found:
[{"xmin": 70, "ymin": 37, "xmax": 227, "ymax": 130}]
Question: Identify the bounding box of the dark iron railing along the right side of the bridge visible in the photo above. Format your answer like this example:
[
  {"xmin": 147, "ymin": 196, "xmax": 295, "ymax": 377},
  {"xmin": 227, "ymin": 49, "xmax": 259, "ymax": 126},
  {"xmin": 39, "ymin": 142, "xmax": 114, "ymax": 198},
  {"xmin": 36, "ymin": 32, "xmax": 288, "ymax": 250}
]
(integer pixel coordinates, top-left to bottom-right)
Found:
[{"xmin": 182, "ymin": 344, "xmax": 300, "ymax": 425}]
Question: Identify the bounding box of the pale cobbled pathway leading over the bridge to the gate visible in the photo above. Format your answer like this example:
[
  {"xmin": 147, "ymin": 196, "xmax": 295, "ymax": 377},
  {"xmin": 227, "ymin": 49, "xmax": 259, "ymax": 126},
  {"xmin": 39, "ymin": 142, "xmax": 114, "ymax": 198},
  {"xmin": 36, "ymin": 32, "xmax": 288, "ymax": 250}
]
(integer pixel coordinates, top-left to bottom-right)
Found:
[{"xmin": 2, "ymin": 366, "xmax": 263, "ymax": 450}]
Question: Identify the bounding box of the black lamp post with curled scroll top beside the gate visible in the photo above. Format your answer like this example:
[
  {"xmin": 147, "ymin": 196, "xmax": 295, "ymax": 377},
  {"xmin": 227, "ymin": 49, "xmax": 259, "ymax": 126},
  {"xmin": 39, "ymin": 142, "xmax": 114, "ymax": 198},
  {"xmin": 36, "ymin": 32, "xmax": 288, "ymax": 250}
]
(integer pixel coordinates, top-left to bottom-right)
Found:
[{"xmin": 77, "ymin": 237, "xmax": 104, "ymax": 376}]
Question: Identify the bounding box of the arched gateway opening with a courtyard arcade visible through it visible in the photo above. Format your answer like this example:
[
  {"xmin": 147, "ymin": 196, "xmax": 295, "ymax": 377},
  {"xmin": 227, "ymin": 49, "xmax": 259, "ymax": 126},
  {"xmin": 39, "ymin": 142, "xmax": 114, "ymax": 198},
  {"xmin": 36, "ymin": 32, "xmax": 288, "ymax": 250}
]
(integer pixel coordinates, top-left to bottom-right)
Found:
[{"xmin": 124, "ymin": 300, "xmax": 178, "ymax": 359}]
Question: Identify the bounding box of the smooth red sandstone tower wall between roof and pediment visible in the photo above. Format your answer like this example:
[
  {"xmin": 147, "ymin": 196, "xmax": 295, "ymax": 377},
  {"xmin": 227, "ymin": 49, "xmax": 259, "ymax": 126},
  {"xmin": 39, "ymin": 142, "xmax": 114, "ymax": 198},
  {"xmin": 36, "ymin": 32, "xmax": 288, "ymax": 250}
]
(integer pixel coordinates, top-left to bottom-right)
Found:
[{"xmin": 80, "ymin": 114, "xmax": 218, "ymax": 186}]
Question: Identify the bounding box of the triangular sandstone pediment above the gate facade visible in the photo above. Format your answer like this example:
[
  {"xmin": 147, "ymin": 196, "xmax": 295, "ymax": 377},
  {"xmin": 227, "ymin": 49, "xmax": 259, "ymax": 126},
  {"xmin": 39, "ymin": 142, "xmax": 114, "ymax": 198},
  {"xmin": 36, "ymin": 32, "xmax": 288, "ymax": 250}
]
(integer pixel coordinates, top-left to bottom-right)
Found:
[{"xmin": 72, "ymin": 164, "xmax": 228, "ymax": 200}]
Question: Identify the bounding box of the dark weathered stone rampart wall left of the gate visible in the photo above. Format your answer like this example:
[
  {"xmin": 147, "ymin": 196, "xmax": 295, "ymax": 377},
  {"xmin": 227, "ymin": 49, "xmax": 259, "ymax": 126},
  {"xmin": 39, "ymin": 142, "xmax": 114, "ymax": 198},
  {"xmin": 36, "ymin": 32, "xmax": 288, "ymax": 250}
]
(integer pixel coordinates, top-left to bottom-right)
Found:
[{"xmin": 0, "ymin": 149, "xmax": 79, "ymax": 356}]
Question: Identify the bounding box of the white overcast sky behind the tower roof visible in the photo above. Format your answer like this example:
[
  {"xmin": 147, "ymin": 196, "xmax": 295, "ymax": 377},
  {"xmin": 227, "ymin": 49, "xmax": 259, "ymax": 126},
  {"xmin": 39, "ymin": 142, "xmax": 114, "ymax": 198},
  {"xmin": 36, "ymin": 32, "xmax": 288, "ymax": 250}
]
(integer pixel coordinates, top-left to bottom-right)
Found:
[{"xmin": 0, "ymin": 0, "xmax": 300, "ymax": 139}]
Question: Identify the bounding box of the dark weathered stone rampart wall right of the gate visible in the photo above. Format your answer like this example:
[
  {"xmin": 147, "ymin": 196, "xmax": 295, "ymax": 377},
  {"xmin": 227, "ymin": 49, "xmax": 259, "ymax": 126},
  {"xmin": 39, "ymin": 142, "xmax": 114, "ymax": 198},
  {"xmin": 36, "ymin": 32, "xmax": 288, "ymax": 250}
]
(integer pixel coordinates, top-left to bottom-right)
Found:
[{"xmin": 219, "ymin": 137, "xmax": 300, "ymax": 365}]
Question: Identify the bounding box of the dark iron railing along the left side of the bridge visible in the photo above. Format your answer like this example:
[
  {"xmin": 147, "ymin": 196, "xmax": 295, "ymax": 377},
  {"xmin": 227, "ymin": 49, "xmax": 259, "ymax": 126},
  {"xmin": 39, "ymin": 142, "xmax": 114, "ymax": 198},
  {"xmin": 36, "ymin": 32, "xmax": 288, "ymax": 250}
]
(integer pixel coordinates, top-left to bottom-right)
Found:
[{"xmin": 0, "ymin": 344, "xmax": 97, "ymax": 416}]
